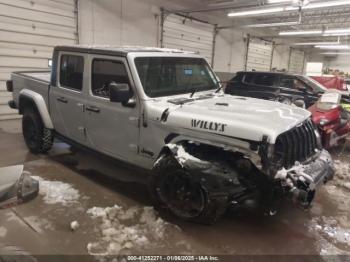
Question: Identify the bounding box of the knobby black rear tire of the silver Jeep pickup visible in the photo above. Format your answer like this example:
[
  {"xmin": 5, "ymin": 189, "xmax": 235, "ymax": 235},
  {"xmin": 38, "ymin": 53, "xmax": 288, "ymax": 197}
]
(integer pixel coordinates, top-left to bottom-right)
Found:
[{"xmin": 22, "ymin": 109, "xmax": 54, "ymax": 154}]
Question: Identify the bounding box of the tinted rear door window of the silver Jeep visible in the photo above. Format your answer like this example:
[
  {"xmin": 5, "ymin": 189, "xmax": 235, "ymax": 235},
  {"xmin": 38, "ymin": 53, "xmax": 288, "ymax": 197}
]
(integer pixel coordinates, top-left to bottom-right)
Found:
[{"xmin": 60, "ymin": 55, "xmax": 84, "ymax": 91}]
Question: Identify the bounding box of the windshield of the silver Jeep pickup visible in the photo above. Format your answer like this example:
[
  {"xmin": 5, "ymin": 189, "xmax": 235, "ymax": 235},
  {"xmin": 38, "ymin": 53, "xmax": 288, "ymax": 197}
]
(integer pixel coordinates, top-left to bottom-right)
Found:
[{"xmin": 135, "ymin": 57, "xmax": 219, "ymax": 97}]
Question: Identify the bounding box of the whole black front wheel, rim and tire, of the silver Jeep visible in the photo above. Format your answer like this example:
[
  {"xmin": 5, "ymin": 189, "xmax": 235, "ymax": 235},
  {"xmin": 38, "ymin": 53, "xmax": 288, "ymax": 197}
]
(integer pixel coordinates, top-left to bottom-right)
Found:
[{"xmin": 149, "ymin": 154, "xmax": 227, "ymax": 224}]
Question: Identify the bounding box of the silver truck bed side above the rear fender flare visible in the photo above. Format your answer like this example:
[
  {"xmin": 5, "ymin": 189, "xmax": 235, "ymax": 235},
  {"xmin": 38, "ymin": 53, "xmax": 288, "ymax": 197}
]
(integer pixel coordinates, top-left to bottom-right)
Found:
[{"xmin": 11, "ymin": 71, "xmax": 51, "ymax": 106}]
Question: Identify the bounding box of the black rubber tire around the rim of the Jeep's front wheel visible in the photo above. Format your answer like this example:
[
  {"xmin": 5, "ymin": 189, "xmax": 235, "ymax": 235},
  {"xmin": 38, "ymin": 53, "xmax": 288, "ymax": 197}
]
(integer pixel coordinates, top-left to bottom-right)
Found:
[{"xmin": 148, "ymin": 154, "xmax": 227, "ymax": 224}]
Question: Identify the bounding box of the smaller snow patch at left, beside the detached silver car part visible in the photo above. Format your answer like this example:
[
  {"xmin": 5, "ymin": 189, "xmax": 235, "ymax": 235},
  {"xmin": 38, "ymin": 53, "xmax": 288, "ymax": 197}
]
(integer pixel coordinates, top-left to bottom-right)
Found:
[{"xmin": 32, "ymin": 176, "xmax": 80, "ymax": 206}]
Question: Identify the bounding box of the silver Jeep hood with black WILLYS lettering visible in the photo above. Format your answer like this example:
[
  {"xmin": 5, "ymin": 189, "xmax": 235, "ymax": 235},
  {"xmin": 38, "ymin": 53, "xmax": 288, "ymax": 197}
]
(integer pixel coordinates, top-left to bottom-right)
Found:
[{"xmin": 149, "ymin": 95, "xmax": 311, "ymax": 144}]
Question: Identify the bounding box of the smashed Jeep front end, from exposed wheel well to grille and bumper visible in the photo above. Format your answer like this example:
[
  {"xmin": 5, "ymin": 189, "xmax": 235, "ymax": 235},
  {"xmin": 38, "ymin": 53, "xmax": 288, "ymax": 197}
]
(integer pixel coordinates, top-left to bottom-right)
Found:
[{"xmin": 155, "ymin": 118, "xmax": 334, "ymax": 219}]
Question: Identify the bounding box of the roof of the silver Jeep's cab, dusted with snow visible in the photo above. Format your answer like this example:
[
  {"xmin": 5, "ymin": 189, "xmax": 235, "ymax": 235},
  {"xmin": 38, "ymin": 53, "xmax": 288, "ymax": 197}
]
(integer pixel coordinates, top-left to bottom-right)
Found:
[{"xmin": 55, "ymin": 45, "xmax": 195, "ymax": 56}]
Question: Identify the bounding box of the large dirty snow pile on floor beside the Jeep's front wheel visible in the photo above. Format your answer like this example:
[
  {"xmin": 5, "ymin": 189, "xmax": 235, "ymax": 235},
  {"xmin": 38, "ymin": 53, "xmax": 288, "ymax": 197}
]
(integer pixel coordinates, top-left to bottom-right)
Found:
[{"xmin": 87, "ymin": 205, "xmax": 183, "ymax": 255}]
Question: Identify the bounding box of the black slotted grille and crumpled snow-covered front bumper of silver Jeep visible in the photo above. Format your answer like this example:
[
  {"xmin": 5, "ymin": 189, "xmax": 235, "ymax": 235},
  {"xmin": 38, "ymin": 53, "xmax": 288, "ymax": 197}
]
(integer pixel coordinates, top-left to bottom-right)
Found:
[{"xmin": 260, "ymin": 120, "xmax": 335, "ymax": 208}]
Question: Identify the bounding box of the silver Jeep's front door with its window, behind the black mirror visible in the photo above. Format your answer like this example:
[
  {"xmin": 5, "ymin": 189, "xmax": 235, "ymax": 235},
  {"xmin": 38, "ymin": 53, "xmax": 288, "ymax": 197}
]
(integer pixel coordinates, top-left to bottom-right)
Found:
[{"xmin": 86, "ymin": 55, "xmax": 139, "ymax": 162}]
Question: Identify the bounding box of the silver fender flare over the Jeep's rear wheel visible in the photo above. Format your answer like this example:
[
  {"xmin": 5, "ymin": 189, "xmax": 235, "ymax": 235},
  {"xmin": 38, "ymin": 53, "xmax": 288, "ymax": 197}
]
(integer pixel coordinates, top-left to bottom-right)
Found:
[{"xmin": 18, "ymin": 89, "xmax": 54, "ymax": 129}]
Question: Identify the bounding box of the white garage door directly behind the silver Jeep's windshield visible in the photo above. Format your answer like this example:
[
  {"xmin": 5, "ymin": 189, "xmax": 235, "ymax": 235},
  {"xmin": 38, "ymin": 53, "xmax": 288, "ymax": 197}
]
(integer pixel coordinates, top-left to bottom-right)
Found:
[{"xmin": 162, "ymin": 14, "xmax": 215, "ymax": 64}]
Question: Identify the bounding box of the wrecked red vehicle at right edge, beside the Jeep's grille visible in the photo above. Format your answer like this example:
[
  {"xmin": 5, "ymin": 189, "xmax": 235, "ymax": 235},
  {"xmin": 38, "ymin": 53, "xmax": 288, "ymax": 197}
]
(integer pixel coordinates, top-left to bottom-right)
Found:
[{"xmin": 308, "ymin": 92, "xmax": 350, "ymax": 149}]
